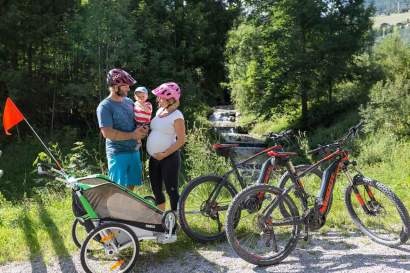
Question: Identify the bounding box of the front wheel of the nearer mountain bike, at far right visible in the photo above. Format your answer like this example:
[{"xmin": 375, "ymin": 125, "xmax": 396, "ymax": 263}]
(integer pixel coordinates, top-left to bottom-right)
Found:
[{"xmin": 345, "ymin": 177, "xmax": 409, "ymax": 246}]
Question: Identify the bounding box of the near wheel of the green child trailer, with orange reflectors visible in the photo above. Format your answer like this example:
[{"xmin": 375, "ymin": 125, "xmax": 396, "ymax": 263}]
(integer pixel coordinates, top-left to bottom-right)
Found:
[{"xmin": 80, "ymin": 223, "xmax": 139, "ymax": 273}]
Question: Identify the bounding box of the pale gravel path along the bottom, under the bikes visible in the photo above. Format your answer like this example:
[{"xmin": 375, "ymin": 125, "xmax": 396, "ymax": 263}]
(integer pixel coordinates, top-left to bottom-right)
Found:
[{"xmin": 0, "ymin": 232, "xmax": 410, "ymax": 273}]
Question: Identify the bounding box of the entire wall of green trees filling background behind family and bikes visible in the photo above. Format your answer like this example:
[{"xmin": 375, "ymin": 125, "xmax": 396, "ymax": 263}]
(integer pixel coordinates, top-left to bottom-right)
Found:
[{"xmin": 0, "ymin": 0, "xmax": 410, "ymax": 197}]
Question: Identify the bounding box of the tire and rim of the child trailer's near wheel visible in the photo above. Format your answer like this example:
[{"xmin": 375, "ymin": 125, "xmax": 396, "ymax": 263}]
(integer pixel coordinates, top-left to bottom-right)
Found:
[{"xmin": 80, "ymin": 223, "xmax": 140, "ymax": 273}]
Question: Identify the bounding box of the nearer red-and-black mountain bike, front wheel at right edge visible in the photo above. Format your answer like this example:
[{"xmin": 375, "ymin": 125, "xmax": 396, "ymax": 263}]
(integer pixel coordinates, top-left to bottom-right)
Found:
[{"xmin": 226, "ymin": 123, "xmax": 410, "ymax": 265}]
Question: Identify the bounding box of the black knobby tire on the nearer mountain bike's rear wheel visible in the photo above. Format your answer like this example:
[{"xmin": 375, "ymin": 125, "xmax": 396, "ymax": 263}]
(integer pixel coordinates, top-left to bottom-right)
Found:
[{"xmin": 225, "ymin": 184, "xmax": 301, "ymax": 266}]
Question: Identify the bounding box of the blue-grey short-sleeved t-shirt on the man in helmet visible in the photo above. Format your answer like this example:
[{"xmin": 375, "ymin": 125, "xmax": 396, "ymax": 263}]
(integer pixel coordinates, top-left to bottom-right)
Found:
[{"xmin": 97, "ymin": 98, "xmax": 137, "ymax": 157}]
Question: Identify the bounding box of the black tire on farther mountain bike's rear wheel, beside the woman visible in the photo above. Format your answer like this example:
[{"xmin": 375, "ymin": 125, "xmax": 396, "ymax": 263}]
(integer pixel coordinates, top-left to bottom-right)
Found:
[{"xmin": 178, "ymin": 175, "xmax": 237, "ymax": 243}]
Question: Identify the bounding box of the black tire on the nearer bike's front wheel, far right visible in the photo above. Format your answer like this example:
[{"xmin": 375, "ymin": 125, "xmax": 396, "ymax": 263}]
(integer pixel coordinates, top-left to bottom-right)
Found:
[{"xmin": 344, "ymin": 177, "xmax": 410, "ymax": 247}]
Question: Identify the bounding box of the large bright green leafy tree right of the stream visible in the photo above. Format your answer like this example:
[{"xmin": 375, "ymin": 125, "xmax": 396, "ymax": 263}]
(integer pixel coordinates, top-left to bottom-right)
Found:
[{"xmin": 227, "ymin": 0, "xmax": 372, "ymax": 126}]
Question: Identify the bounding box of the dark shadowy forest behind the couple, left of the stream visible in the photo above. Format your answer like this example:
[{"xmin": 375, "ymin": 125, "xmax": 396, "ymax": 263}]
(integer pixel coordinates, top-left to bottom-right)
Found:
[{"xmin": 0, "ymin": 0, "xmax": 240, "ymax": 138}]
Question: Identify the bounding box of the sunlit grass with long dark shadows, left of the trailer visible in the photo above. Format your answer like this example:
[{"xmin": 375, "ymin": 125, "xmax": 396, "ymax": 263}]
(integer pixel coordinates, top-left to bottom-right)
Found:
[{"xmin": 0, "ymin": 192, "xmax": 76, "ymax": 264}]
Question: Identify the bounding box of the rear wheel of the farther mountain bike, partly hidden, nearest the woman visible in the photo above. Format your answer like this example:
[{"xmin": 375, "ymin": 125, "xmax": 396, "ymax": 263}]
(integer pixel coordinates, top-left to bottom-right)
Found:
[{"xmin": 178, "ymin": 175, "xmax": 236, "ymax": 242}]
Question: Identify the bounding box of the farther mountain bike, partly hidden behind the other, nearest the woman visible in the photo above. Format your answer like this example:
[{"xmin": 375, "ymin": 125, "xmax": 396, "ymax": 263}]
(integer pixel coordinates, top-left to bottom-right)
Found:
[{"xmin": 178, "ymin": 131, "xmax": 322, "ymax": 242}]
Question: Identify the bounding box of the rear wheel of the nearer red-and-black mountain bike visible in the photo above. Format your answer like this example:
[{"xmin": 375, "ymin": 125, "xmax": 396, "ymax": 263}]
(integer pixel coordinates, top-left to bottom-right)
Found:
[{"xmin": 226, "ymin": 185, "xmax": 301, "ymax": 265}]
